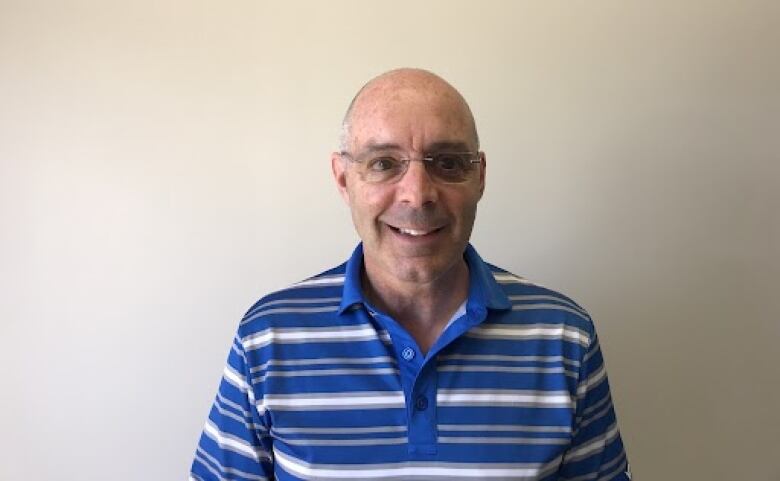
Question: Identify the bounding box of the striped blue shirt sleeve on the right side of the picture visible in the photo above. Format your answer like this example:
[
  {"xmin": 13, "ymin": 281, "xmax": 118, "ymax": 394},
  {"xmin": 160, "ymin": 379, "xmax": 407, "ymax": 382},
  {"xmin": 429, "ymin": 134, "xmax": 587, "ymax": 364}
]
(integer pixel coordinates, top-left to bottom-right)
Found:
[{"xmin": 559, "ymin": 332, "xmax": 631, "ymax": 481}]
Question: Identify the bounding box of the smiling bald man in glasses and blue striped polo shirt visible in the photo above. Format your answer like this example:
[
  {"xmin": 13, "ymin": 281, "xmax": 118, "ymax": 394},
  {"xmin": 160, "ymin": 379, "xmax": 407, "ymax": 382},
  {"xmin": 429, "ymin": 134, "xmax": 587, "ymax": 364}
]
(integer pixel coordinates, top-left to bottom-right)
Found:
[{"xmin": 191, "ymin": 69, "xmax": 629, "ymax": 481}]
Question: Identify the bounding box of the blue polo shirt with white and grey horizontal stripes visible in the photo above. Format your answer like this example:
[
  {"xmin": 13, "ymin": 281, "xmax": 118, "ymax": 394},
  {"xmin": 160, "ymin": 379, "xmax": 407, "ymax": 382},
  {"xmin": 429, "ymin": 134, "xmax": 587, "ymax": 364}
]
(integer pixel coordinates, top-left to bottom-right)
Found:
[{"xmin": 190, "ymin": 245, "xmax": 630, "ymax": 481}]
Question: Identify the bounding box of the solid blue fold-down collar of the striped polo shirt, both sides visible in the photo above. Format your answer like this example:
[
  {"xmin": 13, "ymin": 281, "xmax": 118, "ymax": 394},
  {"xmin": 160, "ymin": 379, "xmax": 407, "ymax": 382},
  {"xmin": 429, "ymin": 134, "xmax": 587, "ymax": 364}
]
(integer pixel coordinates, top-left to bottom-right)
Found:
[{"xmin": 338, "ymin": 242, "xmax": 512, "ymax": 314}]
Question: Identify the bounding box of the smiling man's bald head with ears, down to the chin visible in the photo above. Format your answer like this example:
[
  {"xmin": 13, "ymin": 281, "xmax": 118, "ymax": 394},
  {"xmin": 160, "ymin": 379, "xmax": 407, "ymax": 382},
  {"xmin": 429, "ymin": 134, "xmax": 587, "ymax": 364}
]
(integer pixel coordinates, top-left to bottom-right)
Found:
[{"xmin": 331, "ymin": 69, "xmax": 485, "ymax": 288}]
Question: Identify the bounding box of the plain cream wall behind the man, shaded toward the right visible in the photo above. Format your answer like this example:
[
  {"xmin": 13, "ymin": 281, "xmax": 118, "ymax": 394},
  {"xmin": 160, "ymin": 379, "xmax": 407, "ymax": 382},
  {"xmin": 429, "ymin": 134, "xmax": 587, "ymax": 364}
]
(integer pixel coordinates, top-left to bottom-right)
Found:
[{"xmin": 0, "ymin": 0, "xmax": 780, "ymax": 481}]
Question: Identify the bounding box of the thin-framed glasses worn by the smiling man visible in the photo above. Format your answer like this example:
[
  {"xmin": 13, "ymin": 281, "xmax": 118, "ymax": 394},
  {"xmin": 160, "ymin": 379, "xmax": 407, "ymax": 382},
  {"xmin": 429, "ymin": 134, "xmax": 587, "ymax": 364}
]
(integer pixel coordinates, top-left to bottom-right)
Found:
[{"xmin": 339, "ymin": 151, "xmax": 482, "ymax": 184}]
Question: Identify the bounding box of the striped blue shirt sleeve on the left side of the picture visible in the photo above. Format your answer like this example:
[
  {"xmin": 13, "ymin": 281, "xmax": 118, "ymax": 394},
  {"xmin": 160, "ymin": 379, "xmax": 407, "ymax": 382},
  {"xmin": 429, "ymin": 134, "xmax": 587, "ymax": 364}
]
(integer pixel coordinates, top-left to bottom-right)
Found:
[{"xmin": 190, "ymin": 336, "xmax": 274, "ymax": 481}]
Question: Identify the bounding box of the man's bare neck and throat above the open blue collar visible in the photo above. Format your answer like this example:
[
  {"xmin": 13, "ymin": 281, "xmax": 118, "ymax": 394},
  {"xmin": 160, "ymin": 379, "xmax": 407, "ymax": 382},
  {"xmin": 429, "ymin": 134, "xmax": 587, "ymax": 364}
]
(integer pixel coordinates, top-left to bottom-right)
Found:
[{"xmin": 362, "ymin": 259, "xmax": 469, "ymax": 353}]
